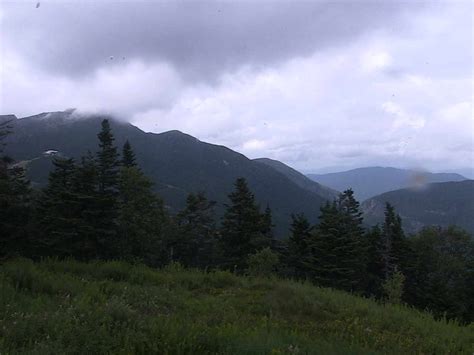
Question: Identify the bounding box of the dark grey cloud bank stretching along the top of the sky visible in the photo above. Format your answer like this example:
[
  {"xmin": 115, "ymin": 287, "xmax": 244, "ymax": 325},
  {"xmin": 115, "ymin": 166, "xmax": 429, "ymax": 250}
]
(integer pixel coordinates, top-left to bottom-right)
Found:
[{"xmin": 2, "ymin": 1, "xmax": 420, "ymax": 80}]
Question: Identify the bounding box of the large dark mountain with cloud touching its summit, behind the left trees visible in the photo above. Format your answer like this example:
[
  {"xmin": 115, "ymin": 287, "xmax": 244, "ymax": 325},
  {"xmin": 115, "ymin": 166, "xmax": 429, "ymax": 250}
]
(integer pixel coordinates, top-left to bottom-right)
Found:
[{"xmin": 0, "ymin": 111, "xmax": 326, "ymax": 236}]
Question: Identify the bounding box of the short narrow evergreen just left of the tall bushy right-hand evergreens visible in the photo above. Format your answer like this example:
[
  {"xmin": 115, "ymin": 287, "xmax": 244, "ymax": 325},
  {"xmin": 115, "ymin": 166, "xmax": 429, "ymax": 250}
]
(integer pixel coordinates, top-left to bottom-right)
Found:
[{"xmin": 286, "ymin": 214, "xmax": 313, "ymax": 279}]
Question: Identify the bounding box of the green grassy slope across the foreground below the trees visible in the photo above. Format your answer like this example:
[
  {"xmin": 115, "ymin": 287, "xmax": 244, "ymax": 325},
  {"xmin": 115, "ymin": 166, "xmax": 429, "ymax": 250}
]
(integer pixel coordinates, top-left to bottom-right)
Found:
[{"xmin": 0, "ymin": 260, "xmax": 474, "ymax": 354}]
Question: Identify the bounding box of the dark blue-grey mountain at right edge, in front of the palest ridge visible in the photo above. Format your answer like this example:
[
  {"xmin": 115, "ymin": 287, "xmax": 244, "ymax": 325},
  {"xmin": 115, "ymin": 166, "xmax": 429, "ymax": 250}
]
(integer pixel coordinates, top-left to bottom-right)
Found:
[{"xmin": 362, "ymin": 180, "xmax": 474, "ymax": 233}]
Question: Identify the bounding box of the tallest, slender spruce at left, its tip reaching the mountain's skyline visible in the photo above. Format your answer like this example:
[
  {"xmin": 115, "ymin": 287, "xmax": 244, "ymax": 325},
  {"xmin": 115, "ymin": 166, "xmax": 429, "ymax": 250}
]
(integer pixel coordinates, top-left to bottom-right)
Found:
[{"xmin": 97, "ymin": 119, "xmax": 120, "ymax": 259}]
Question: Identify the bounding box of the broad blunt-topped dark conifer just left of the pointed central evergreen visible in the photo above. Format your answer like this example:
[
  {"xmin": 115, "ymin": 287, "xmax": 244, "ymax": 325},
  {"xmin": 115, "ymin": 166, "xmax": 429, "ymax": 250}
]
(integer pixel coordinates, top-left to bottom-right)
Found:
[{"xmin": 175, "ymin": 192, "xmax": 218, "ymax": 268}]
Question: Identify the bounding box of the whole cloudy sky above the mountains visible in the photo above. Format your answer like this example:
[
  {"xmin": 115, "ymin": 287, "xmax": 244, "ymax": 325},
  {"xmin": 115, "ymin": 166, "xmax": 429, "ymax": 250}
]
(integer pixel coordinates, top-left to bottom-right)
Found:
[{"xmin": 0, "ymin": 0, "xmax": 474, "ymax": 178}]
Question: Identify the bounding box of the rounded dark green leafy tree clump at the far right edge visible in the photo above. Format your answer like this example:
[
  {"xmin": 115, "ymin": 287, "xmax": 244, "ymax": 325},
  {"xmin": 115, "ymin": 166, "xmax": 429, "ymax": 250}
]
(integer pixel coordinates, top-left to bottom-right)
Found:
[{"xmin": 407, "ymin": 227, "xmax": 474, "ymax": 322}]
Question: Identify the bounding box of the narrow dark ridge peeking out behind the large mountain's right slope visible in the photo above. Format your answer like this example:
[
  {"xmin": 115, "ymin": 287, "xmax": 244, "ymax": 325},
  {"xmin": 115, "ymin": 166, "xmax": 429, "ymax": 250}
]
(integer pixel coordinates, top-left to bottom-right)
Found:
[{"xmin": 253, "ymin": 158, "xmax": 339, "ymax": 200}]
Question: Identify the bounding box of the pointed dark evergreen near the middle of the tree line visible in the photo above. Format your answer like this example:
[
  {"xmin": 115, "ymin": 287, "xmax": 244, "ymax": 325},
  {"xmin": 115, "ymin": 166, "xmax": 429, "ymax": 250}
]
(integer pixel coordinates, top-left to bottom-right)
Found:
[{"xmin": 221, "ymin": 178, "xmax": 268, "ymax": 270}]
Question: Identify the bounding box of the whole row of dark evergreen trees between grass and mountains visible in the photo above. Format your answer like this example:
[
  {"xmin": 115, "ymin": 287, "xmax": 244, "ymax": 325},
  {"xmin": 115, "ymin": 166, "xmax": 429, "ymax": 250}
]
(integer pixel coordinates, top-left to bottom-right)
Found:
[{"xmin": 0, "ymin": 120, "xmax": 474, "ymax": 322}]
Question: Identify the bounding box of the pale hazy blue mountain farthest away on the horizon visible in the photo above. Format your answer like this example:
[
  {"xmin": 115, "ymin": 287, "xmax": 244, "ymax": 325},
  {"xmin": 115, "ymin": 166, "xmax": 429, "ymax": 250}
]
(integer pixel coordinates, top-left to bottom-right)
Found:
[{"xmin": 307, "ymin": 167, "xmax": 466, "ymax": 201}]
